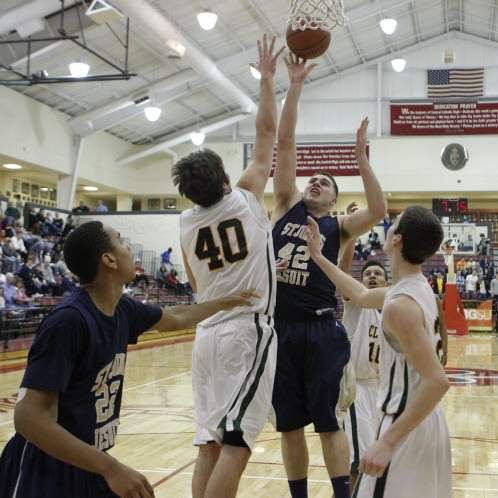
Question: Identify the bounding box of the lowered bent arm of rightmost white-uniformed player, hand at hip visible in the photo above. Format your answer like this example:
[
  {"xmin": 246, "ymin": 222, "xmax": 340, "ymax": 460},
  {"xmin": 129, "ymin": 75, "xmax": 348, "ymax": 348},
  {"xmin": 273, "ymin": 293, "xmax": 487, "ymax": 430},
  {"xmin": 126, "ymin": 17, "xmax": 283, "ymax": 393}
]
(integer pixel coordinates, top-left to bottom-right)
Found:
[{"xmin": 360, "ymin": 296, "xmax": 450, "ymax": 477}]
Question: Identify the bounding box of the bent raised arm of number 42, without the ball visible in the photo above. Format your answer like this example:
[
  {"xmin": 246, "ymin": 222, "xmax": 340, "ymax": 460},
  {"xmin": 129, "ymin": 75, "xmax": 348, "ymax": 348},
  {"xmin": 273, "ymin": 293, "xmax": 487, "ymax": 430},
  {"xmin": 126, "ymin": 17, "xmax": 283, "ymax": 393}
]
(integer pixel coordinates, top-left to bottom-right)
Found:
[{"xmin": 341, "ymin": 118, "xmax": 387, "ymax": 243}]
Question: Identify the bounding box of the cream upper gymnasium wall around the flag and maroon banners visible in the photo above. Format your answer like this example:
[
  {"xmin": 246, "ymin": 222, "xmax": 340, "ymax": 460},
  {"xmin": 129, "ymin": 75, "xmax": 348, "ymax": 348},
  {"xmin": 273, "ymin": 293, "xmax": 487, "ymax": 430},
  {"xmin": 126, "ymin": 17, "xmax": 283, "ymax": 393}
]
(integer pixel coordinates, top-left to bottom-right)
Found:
[{"xmin": 0, "ymin": 33, "xmax": 498, "ymax": 198}]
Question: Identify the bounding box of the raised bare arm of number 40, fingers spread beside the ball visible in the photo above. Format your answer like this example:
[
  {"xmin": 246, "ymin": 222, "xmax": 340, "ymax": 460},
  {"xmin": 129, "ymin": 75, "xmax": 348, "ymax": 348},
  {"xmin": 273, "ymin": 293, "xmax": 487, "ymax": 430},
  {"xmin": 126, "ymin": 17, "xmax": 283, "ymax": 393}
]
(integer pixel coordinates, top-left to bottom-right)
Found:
[{"xmin": 237, "ymin": 35, "xmax": 284, "ymax": 203}]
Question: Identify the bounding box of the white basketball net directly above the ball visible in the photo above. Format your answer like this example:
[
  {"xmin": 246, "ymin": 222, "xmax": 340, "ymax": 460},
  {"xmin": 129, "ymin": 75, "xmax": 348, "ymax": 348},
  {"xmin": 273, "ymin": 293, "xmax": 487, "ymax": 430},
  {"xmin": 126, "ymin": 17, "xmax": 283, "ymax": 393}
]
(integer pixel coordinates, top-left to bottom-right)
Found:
[{"xmin": 287, "ymin": 0, "xmax": 348, "ymax": 31}]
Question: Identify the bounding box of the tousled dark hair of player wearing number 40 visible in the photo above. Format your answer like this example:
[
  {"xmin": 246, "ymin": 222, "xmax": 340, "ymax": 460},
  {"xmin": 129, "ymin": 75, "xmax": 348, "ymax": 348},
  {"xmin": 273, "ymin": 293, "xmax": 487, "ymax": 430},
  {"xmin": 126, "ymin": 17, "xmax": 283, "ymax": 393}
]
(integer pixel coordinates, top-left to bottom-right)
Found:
[{"xmin": 172, "ymin": 149, "xmax": 230, "ymax": 207}]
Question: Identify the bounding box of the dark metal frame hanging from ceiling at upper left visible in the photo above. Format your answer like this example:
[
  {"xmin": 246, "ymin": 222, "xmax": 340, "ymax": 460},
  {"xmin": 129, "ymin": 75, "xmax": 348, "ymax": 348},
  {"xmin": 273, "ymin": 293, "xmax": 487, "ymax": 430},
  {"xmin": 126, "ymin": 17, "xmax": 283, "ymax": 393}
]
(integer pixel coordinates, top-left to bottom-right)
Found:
[{"xmin": 0, "ymin": 0, "xmax": 137, "ymax": 86}]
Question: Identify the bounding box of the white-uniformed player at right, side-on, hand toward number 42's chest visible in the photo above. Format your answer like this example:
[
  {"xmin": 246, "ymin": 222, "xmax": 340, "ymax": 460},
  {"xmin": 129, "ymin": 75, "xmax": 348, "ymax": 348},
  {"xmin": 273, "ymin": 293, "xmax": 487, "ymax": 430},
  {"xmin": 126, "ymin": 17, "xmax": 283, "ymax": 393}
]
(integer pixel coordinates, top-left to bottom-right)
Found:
[{"xmin": 308, "ymin": 206, "xmax": 452, "ymax": 498}]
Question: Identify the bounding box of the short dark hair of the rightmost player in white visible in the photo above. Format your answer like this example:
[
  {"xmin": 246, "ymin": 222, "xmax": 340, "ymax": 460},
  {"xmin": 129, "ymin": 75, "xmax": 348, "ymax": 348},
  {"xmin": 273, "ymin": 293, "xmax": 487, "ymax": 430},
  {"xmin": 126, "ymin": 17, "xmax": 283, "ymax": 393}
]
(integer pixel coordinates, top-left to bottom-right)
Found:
[{"xmin": 395, "ymin": 206, "xmax": 444, "ymax": 265}]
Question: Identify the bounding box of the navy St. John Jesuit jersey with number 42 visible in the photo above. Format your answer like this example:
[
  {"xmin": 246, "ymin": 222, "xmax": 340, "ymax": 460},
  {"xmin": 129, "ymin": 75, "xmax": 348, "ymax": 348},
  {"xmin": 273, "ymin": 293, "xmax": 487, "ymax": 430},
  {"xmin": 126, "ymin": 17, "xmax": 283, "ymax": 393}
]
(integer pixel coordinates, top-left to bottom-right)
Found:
[{"xmin": 273, "ymin": 201, "xmax": 340, "ymax": 320}]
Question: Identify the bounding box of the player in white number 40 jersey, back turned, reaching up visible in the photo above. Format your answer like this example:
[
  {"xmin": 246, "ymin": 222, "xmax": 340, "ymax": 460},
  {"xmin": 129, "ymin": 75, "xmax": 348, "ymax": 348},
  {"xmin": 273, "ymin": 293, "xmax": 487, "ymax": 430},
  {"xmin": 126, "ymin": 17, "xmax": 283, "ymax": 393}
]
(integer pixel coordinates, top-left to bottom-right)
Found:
[{"xmin": 173, "ymin": 36, "xmax": 282, "ymax": 498}]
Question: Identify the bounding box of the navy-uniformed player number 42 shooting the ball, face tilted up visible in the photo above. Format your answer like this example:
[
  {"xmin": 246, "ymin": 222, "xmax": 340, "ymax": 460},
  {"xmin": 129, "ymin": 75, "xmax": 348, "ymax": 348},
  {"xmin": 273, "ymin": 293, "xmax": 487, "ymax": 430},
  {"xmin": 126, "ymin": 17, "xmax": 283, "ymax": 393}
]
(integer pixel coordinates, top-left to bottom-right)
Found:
[{"xmin": 272, "ymin": 55, "xmax": 386, "ymax": 498}]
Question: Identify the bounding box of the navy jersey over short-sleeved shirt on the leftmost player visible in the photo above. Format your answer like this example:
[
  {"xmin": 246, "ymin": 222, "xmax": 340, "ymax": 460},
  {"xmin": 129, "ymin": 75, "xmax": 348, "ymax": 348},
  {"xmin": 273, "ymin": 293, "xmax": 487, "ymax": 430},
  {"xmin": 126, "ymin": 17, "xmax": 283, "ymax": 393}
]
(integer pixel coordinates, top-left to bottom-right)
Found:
[{"xmin": 21, "ymin": 289, "xmax": 162, "ymax": 450}]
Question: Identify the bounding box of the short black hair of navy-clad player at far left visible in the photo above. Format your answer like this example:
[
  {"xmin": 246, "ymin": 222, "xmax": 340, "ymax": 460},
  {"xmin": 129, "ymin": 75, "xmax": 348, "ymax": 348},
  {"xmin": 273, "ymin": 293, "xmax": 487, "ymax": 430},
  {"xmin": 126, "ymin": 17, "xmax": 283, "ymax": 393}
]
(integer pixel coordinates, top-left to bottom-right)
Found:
[{"xmin": 64, "ymin": 221, "xmax": 113, "ymax": 284}]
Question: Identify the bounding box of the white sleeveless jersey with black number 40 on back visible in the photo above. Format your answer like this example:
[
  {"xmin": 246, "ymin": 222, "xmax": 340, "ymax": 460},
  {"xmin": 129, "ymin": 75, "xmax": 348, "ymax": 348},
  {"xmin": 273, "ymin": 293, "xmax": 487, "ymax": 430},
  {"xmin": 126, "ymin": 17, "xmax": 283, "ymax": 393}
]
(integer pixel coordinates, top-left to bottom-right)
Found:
[{"xmin": 180, "ymin": 188, "xmax": 276, "ymax": 326}]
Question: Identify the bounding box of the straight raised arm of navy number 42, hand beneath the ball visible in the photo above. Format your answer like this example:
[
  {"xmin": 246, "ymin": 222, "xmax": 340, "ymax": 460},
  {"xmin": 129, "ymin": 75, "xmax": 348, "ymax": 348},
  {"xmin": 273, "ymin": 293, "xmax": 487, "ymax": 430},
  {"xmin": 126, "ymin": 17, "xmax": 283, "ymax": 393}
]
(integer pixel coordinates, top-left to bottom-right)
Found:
[{"xmin": 272, "ymin": 53, "xmax": 316, "ymax": 222}]
